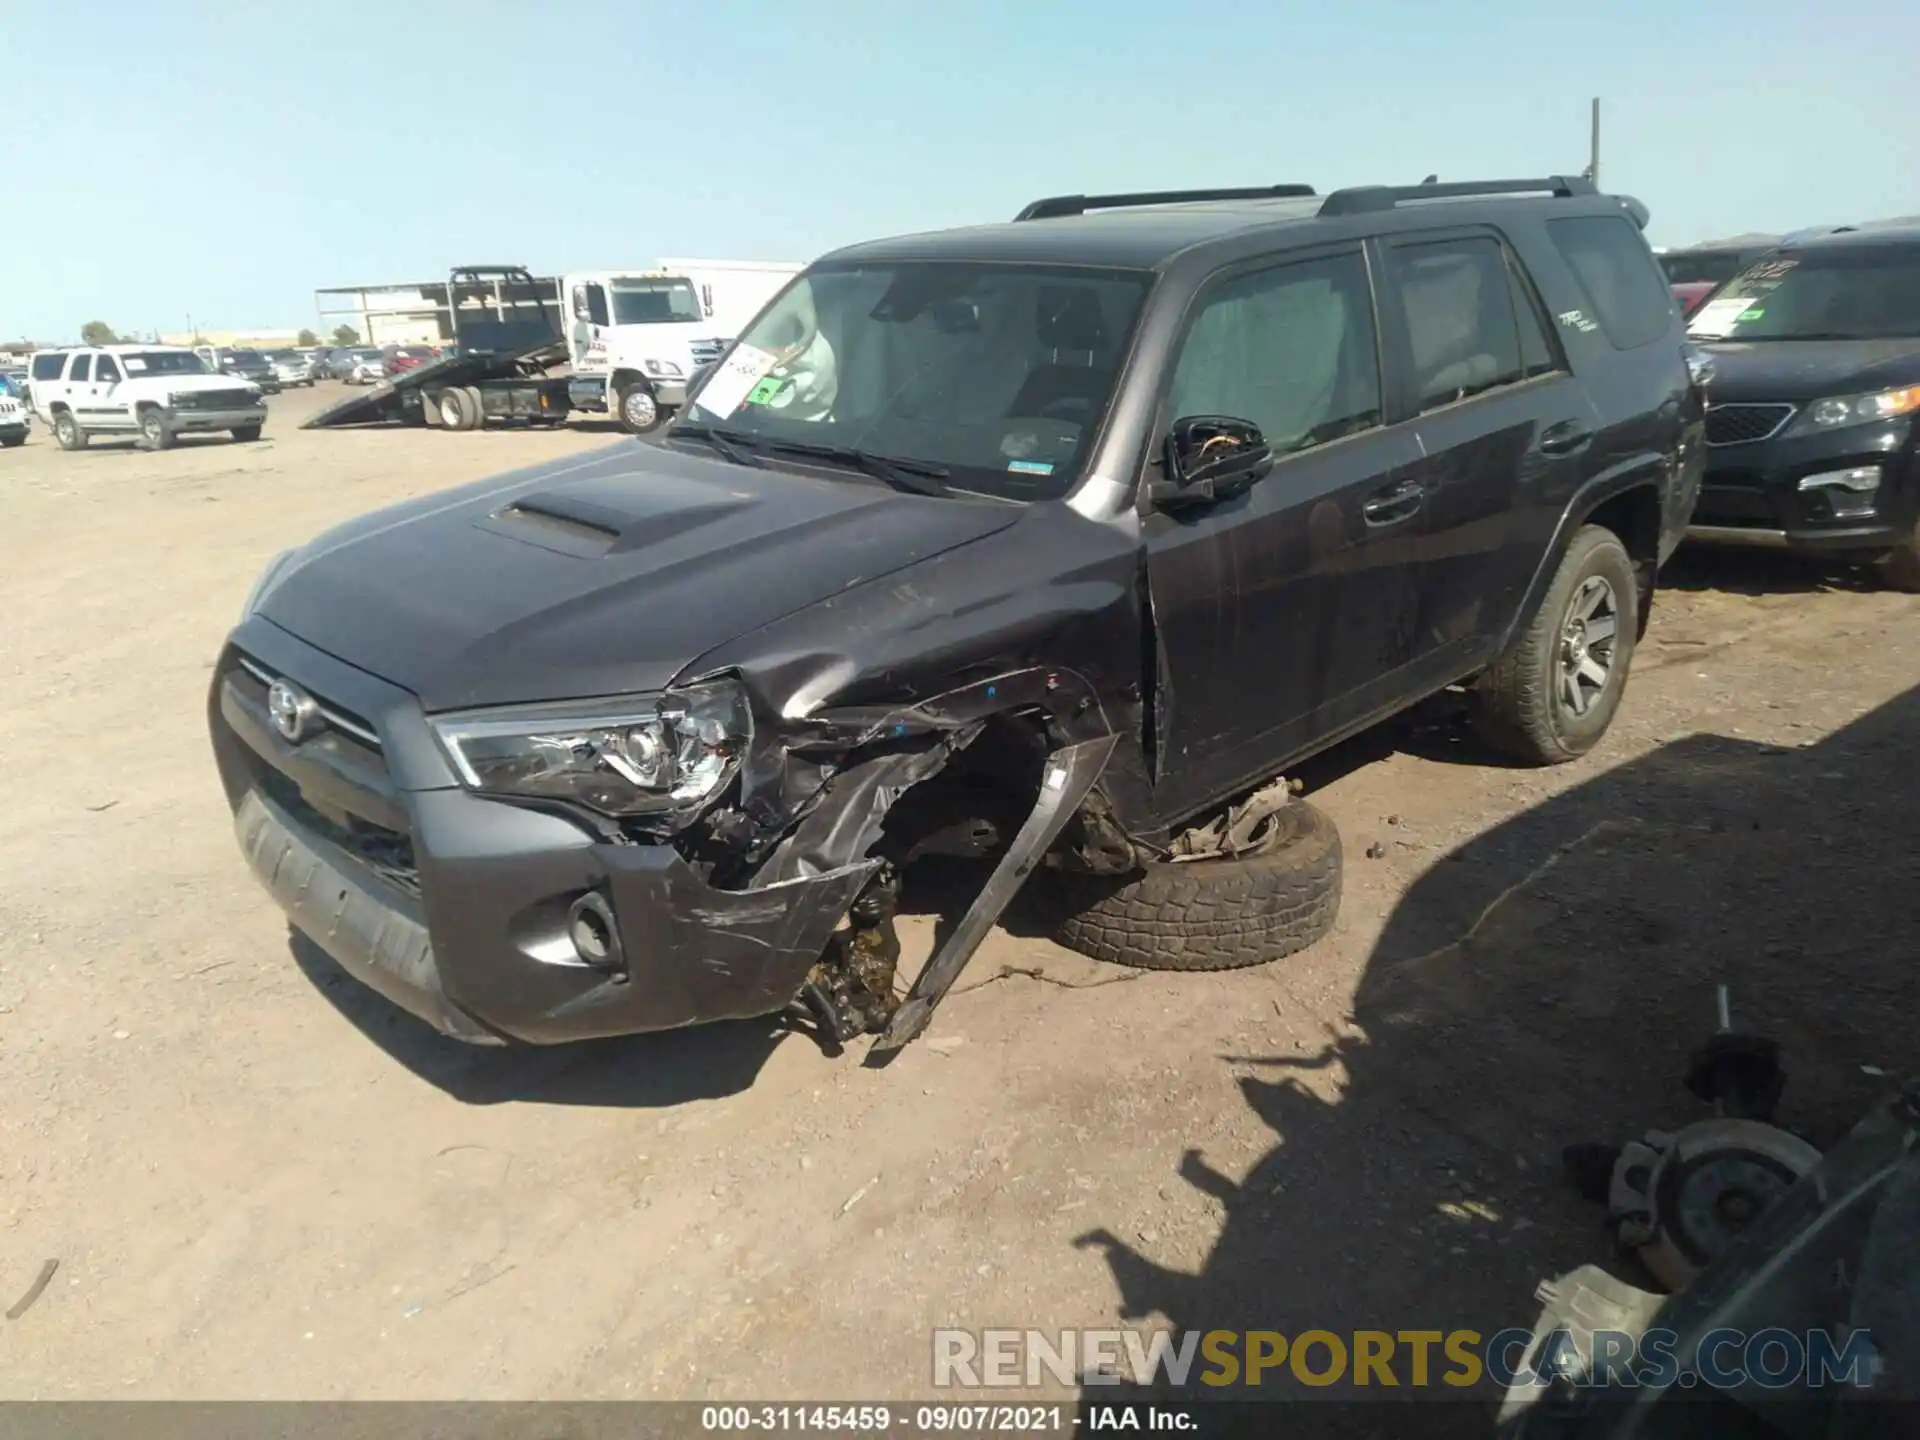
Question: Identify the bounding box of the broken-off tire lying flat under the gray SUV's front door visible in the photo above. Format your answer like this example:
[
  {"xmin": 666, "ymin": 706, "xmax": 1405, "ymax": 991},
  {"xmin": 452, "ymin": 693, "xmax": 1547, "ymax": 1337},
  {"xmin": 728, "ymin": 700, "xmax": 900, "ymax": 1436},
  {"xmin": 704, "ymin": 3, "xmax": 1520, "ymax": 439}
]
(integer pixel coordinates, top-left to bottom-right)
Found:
[{"xmin": 1054, "ymin": 801, "xmax": 1340, "ymax": 970}]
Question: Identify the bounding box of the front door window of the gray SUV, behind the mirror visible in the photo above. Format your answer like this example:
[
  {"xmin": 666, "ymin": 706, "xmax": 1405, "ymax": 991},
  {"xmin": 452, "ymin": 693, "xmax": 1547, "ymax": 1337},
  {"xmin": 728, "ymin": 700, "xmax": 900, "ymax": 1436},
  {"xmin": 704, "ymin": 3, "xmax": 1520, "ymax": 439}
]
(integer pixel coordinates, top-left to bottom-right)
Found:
[{"xmin": 1169, "ymin": 252, "xmax": 1380, "ymax": 455}]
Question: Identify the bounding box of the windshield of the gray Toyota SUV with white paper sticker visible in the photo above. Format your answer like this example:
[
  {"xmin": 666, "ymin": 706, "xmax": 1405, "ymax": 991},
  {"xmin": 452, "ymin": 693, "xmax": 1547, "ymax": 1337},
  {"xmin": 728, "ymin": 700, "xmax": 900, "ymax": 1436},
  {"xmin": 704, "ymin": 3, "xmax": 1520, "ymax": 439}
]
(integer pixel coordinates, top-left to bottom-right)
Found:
[{"xmin": 685, "ymin": 261, "xmax": 1152, "ymax": 499}]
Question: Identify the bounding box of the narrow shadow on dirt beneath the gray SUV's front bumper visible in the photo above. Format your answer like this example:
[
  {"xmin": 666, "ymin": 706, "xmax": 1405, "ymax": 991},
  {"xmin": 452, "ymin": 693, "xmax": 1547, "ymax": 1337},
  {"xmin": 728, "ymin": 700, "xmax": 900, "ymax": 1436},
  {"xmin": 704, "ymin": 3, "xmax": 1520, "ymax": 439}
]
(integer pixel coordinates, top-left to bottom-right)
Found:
[{"xmin": 288, "ymin": 931, "xmax": 787, "ymax": 1110}]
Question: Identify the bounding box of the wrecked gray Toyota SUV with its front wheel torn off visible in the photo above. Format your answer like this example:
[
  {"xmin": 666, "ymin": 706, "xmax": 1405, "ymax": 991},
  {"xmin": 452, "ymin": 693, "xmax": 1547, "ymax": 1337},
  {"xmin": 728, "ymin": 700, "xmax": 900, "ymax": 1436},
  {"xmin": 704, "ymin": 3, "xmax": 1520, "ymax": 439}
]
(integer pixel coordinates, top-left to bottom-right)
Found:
[{"xmin": 209, "ymin": 177, "xmax": 1705, "ymax": 1054}]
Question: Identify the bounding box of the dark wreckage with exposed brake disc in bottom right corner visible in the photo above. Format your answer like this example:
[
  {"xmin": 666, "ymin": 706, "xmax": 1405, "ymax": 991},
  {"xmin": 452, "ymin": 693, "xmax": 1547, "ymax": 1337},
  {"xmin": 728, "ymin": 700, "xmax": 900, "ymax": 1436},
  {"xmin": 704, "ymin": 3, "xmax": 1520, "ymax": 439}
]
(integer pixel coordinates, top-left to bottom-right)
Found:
[{"xmin": 1500, "ymin": 987, "xmax": 1920, "ymax": 1440}]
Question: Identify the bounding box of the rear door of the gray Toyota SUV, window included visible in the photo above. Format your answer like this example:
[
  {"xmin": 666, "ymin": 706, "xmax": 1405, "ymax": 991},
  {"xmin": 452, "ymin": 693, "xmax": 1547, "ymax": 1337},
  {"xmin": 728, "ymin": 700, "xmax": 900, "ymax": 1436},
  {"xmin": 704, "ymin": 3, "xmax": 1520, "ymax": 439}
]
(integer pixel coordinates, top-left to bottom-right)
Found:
[{"xmin": 1382, "ymin": 227, "xmax": 1599, "ymax": 687}]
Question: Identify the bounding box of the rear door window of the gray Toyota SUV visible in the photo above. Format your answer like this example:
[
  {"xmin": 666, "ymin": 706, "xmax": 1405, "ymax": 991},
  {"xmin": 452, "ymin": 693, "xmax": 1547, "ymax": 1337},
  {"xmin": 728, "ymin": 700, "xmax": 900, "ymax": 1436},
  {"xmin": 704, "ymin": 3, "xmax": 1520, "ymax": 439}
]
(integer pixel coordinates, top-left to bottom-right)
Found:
[{"xmin": 1390, "ymin": 236, "xmax": 1528, "ymax": 411}]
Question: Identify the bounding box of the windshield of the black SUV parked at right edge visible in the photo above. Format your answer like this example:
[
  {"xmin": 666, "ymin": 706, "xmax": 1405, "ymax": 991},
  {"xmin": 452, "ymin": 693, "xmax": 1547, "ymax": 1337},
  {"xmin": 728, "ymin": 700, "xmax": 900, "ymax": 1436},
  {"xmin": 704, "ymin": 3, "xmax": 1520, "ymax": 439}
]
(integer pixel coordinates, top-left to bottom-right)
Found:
[{"xmin": 1688, "ymin": 246, "xmax": 1920, "ymax": 340}]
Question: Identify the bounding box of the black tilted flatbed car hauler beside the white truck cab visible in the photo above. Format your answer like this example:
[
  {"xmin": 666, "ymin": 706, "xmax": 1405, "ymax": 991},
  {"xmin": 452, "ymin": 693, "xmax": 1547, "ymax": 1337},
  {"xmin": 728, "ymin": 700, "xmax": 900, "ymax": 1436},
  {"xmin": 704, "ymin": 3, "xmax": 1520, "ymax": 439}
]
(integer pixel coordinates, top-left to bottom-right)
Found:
[{"xmin": 301, "ymin": 265, "xmax": 568, "ymax": 430}]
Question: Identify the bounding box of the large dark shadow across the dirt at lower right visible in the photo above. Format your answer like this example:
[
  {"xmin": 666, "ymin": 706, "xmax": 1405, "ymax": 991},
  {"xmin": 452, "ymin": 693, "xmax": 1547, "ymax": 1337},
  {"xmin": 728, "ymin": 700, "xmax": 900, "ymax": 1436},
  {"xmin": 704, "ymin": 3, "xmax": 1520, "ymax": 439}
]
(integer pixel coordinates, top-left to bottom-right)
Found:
[{"xmin": 1079, "ymin": 689, "xmax": 1920, "ymax": 1434}]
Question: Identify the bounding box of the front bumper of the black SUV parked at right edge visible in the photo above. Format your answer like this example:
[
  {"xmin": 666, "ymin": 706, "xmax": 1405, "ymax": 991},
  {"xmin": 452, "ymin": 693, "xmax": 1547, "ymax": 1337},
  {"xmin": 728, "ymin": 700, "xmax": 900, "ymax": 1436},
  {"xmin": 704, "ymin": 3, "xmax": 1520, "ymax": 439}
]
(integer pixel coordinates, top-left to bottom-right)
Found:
[{"xmin": 1688, "ymin": 419, "xmax": 1920, "ymax": 555}]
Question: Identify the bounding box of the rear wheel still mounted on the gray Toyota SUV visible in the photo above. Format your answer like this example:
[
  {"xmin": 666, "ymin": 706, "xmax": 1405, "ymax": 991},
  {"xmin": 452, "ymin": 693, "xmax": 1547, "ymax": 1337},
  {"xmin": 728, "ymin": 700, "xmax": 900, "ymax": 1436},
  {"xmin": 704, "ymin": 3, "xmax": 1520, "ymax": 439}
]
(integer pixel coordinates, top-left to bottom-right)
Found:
[{"xmin": 1473, "ymin": 524, "xmax": 1640, "ymax": 764}]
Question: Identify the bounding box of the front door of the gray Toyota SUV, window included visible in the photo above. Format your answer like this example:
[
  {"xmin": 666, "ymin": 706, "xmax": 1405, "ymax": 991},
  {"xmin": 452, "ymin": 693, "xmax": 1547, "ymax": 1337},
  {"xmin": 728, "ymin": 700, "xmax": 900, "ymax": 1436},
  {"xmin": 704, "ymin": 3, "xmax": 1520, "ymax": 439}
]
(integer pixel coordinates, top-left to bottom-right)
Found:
[{"xmin": 1142, "ymin": 244, "xmax": 1423, "ymax": 812}]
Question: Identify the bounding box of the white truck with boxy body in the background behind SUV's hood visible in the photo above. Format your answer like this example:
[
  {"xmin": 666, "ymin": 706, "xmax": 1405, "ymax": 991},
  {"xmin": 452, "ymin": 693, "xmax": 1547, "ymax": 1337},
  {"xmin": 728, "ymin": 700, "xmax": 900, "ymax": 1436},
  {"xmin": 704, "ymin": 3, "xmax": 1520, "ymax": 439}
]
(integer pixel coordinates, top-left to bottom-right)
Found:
[{"xmin": 561, "ymin": 259, "xmax": 806, "ymax": 436}]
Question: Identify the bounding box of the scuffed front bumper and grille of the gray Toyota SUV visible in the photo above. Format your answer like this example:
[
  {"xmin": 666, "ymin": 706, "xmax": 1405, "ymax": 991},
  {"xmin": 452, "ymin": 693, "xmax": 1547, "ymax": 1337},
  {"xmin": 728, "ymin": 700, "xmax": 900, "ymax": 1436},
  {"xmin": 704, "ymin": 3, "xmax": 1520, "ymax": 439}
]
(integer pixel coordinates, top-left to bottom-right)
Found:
[{"xmin": 207, "ymin": 618, "xmax": 874, "ymax": 1044}]
